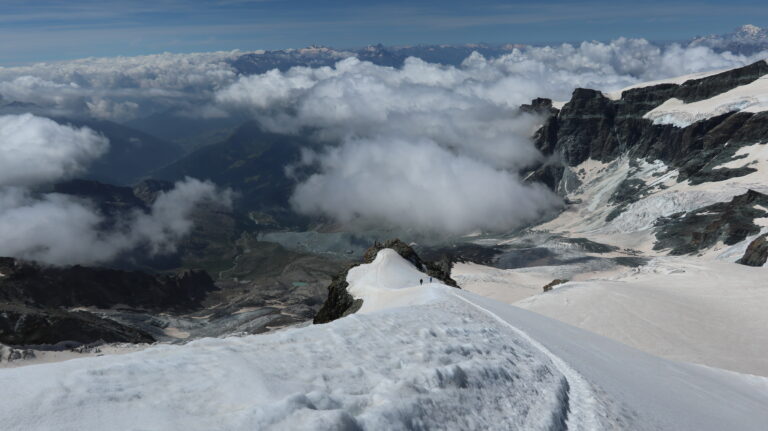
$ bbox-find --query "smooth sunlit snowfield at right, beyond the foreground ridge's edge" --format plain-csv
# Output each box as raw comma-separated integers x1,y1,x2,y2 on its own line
456,256,768,376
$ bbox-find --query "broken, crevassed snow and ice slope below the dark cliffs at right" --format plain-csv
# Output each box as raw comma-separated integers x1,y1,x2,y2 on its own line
534,151,768,253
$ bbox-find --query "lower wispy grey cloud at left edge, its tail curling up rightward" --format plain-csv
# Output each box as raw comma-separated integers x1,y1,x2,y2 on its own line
0,179,230,265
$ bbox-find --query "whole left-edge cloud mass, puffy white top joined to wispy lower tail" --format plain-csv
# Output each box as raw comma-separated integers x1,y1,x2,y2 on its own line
0,114,231,265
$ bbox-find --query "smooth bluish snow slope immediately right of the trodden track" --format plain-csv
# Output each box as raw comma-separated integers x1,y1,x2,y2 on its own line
461,293,768,430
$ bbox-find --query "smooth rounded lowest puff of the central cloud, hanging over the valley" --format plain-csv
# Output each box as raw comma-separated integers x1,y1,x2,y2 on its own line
292,138,560,234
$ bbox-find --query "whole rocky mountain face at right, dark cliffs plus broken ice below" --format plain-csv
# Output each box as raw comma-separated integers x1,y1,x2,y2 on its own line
523,61,768,262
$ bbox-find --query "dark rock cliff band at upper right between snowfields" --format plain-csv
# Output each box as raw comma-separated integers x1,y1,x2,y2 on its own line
526,61,768,194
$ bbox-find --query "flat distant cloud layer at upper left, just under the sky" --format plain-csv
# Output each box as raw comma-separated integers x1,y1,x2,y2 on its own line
0,51,242,121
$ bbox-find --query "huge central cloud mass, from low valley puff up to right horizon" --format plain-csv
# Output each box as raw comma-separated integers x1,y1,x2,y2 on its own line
217,39,768,234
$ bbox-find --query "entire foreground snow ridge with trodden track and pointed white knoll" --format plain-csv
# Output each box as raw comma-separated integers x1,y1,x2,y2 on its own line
0,250,768,430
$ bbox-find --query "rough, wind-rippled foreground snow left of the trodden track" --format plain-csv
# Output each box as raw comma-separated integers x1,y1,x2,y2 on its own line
0,290,568,431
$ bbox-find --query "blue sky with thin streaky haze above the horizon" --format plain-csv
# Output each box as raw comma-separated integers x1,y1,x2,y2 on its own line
0,0,768,65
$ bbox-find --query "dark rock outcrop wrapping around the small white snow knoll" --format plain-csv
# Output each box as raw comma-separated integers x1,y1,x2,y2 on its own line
313,239,458,324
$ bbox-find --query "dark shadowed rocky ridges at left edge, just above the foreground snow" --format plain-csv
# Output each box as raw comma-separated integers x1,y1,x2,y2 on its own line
0,258,217,345
